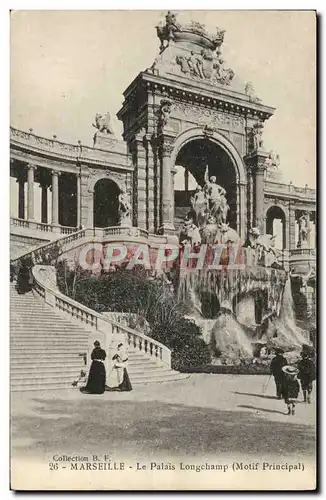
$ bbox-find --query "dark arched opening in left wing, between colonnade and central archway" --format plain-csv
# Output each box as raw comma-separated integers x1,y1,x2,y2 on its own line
94,179,120,227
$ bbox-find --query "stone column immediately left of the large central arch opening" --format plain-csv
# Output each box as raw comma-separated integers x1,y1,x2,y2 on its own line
161,143,175,234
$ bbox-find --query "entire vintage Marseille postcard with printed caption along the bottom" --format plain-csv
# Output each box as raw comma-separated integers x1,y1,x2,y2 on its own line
10,10,317,491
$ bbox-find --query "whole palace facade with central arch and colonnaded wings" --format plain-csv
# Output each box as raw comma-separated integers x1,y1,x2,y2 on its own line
10,13,316,316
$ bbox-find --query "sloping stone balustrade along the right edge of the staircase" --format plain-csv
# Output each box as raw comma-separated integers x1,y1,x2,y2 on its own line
32,265,171,368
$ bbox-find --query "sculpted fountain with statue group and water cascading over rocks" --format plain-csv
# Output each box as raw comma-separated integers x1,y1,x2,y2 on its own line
178,168,307,358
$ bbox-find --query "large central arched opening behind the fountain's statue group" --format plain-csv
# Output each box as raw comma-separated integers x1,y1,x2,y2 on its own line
174,138,238,230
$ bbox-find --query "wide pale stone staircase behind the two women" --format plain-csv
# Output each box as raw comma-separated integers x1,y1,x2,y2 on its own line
10,284,186,391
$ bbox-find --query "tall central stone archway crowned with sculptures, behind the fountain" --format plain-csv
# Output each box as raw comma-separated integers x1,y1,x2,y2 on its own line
117,12,274,239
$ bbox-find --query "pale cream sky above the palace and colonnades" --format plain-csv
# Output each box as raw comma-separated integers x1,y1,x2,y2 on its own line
11,10,316,187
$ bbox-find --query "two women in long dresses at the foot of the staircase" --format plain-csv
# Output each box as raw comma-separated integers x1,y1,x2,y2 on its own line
79,340,132,394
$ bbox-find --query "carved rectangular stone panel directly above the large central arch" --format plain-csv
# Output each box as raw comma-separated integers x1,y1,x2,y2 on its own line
171,102,244,130
